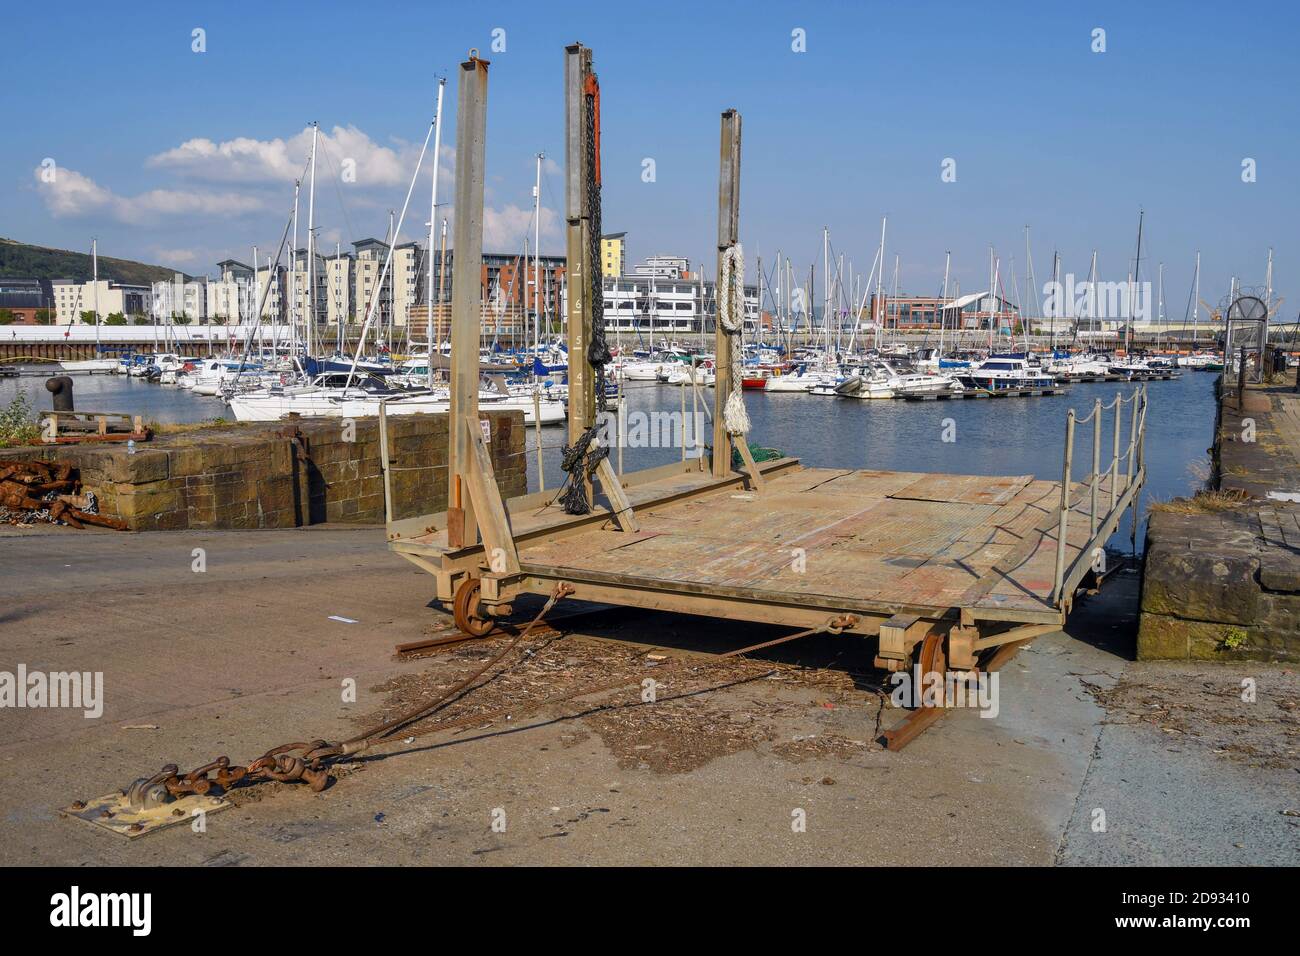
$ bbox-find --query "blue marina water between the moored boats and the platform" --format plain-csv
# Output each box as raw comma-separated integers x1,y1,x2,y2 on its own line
0,372,1217,548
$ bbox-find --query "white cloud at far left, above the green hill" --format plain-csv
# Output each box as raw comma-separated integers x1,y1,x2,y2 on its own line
33,166,263,224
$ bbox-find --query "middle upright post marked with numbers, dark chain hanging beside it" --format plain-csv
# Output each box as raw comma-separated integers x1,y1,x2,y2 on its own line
564,43,595,445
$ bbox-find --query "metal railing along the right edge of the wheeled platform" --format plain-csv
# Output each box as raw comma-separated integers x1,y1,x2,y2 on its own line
1052,385,1147,606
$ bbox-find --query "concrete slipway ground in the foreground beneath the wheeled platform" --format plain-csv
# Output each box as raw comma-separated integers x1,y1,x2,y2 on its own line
0,525,1300,865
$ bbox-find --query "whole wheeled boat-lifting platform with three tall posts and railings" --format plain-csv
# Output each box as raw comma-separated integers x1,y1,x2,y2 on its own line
380,46,1147,747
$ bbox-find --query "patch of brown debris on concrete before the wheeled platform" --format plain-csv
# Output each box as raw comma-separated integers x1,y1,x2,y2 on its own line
355,632,887,774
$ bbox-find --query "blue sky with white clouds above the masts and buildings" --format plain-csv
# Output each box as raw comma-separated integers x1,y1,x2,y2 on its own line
0,1,1300,316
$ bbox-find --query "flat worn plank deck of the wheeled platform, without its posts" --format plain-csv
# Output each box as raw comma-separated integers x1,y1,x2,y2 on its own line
389,458,1127,647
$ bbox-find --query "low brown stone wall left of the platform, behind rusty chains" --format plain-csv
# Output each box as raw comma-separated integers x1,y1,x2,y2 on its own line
0,411,528,531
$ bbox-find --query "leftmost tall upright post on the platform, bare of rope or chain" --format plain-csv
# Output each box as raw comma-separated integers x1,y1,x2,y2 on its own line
447,57,488,542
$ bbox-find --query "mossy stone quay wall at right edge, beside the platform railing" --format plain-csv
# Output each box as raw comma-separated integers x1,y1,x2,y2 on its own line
1138,369,1300,662
